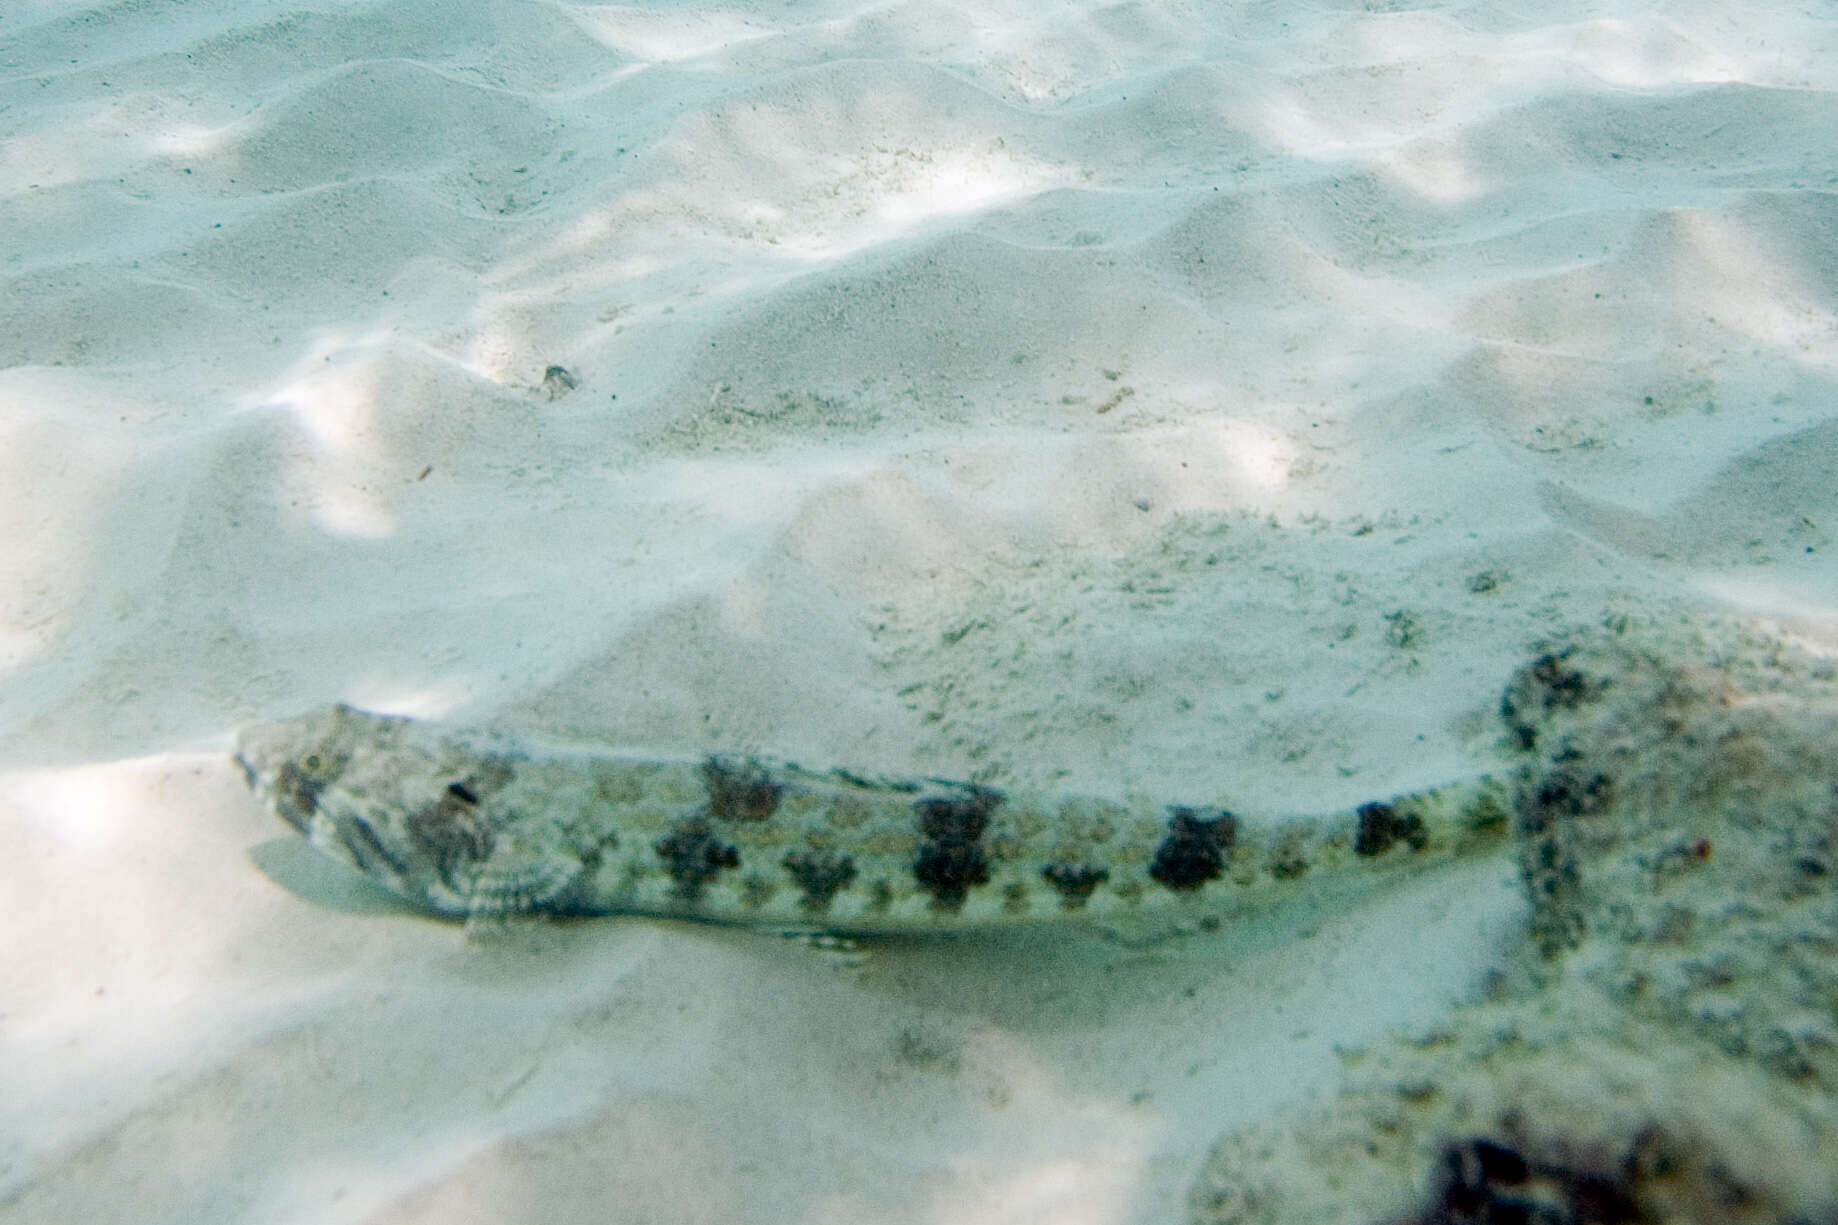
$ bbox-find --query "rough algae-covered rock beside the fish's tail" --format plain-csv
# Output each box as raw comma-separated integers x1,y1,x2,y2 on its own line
1191,620,1838,1225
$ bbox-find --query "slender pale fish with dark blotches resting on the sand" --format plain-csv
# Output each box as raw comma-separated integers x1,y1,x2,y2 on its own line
235,706,1511,933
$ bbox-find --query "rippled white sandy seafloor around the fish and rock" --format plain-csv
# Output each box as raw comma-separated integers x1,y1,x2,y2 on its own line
0,0,1838,1225
